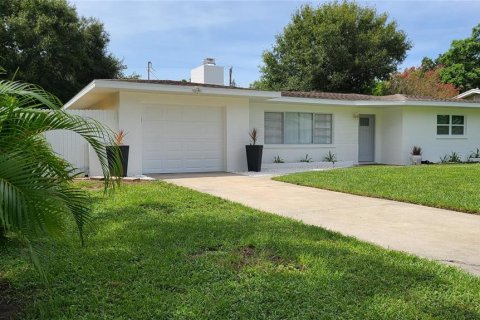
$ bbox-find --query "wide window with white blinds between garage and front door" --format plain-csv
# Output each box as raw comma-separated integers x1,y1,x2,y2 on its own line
264,112,332,144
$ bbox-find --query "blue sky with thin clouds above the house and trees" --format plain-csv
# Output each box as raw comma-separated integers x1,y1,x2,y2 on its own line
70,0,480,87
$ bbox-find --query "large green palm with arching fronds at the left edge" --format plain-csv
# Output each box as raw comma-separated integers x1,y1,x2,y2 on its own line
0,81,120,248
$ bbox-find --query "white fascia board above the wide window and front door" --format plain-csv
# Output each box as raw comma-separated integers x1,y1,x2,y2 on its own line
268,97,480,108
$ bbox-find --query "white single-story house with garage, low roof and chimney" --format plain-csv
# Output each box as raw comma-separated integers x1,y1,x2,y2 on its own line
58,61,480,176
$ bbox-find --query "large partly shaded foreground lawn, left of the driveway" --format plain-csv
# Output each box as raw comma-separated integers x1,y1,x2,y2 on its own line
0,181,480,319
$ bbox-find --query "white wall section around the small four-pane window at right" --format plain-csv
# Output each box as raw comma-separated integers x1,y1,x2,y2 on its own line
401,107,480,164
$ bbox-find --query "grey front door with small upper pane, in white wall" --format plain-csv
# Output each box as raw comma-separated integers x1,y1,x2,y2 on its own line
358,115,375,162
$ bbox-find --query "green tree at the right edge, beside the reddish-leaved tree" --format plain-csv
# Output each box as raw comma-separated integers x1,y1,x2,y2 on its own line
436,24,480,91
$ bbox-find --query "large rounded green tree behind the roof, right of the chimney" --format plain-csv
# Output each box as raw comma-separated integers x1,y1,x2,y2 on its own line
252,1,411,92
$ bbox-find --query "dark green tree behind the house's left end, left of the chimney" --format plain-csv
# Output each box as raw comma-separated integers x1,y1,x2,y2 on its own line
0,0,124,102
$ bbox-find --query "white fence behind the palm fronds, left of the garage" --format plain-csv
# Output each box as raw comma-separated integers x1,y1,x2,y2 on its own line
45,110,118,174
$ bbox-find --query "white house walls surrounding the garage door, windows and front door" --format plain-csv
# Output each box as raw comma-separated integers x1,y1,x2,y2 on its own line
78,87,480,176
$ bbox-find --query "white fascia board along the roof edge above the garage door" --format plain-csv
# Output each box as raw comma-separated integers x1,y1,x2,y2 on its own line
95,80,281,98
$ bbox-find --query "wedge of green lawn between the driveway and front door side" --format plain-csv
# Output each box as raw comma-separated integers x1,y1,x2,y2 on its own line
275,164,480,214
